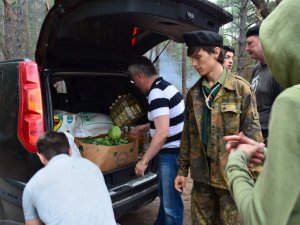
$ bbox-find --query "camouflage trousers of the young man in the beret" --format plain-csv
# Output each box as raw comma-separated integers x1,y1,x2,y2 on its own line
191,182,242,225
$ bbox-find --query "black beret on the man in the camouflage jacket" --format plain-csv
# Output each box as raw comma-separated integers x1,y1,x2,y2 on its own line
183,31,223,47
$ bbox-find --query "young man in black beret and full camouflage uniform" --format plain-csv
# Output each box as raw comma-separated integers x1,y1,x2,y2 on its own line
175,31,262,225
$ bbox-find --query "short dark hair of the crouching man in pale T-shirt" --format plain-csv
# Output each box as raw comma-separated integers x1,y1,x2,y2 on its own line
36,131,70,161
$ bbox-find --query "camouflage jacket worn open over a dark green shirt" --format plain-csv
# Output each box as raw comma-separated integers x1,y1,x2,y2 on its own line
178,73,262,189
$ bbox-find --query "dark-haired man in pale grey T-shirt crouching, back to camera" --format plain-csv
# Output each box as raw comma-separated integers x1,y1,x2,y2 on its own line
22,131,116,225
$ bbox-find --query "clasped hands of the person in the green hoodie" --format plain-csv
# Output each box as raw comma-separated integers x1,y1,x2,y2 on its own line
224,132,265,164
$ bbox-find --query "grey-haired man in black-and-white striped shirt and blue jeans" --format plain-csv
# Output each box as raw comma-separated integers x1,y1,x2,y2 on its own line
128,57,184,225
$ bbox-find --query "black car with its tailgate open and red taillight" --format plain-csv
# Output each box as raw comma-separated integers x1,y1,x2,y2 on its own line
0,0,232,221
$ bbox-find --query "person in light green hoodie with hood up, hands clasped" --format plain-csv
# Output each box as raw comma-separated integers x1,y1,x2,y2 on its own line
224,0,300,225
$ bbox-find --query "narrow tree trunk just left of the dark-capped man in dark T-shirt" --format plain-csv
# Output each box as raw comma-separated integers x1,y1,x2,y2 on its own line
237,0,248,77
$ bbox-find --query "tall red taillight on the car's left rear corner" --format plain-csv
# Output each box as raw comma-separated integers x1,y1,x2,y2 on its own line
18,61,45,153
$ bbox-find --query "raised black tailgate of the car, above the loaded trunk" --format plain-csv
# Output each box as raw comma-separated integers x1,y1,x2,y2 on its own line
36,0,232,70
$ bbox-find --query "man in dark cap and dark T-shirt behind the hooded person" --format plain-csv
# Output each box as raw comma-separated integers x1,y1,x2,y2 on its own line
246,25,283,143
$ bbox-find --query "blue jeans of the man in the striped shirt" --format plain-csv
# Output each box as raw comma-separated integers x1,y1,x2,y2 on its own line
154,153,183,225
